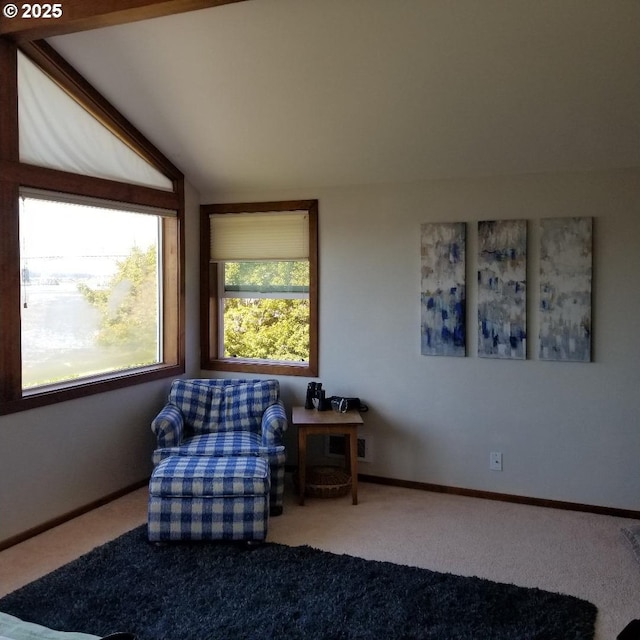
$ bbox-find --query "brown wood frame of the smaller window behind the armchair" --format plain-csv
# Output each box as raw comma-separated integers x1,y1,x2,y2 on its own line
200,200,319,377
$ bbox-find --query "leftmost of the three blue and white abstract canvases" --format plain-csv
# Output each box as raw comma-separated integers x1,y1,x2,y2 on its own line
420,222,466,356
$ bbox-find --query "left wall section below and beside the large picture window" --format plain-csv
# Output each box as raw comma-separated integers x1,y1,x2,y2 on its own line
0,180,199,543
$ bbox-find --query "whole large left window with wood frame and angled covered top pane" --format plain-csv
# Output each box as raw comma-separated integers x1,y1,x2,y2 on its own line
0,42,184,414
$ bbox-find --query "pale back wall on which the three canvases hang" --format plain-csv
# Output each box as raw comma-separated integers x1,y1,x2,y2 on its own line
203,170,640,510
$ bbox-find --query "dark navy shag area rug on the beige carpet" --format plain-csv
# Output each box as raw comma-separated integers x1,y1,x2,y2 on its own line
0,526,596,640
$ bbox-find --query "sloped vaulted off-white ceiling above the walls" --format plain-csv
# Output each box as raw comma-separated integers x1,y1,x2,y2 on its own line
15,0,640,195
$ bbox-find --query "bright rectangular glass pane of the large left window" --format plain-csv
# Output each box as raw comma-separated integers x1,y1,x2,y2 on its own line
20,191,175,390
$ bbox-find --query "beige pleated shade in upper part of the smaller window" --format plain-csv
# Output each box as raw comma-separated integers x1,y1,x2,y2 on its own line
209,211,309,262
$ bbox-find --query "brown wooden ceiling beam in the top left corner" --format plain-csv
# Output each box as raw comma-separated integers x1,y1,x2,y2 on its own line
0,0,247,42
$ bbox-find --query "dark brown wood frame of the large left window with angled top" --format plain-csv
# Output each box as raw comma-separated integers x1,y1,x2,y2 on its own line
0,38,185,415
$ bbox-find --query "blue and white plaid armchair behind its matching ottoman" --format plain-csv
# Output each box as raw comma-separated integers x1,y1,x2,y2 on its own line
151,378,288,515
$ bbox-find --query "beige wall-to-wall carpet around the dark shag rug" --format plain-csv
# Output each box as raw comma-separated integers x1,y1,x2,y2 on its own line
0,483,640,640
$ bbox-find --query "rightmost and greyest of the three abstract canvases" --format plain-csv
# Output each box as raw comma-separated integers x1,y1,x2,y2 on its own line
539,218,593,362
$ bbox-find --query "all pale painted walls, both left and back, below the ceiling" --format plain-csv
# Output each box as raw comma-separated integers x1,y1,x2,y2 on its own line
0,170,640,543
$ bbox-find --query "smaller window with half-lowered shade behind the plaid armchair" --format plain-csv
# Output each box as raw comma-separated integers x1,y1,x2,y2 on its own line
202,200,318,376
